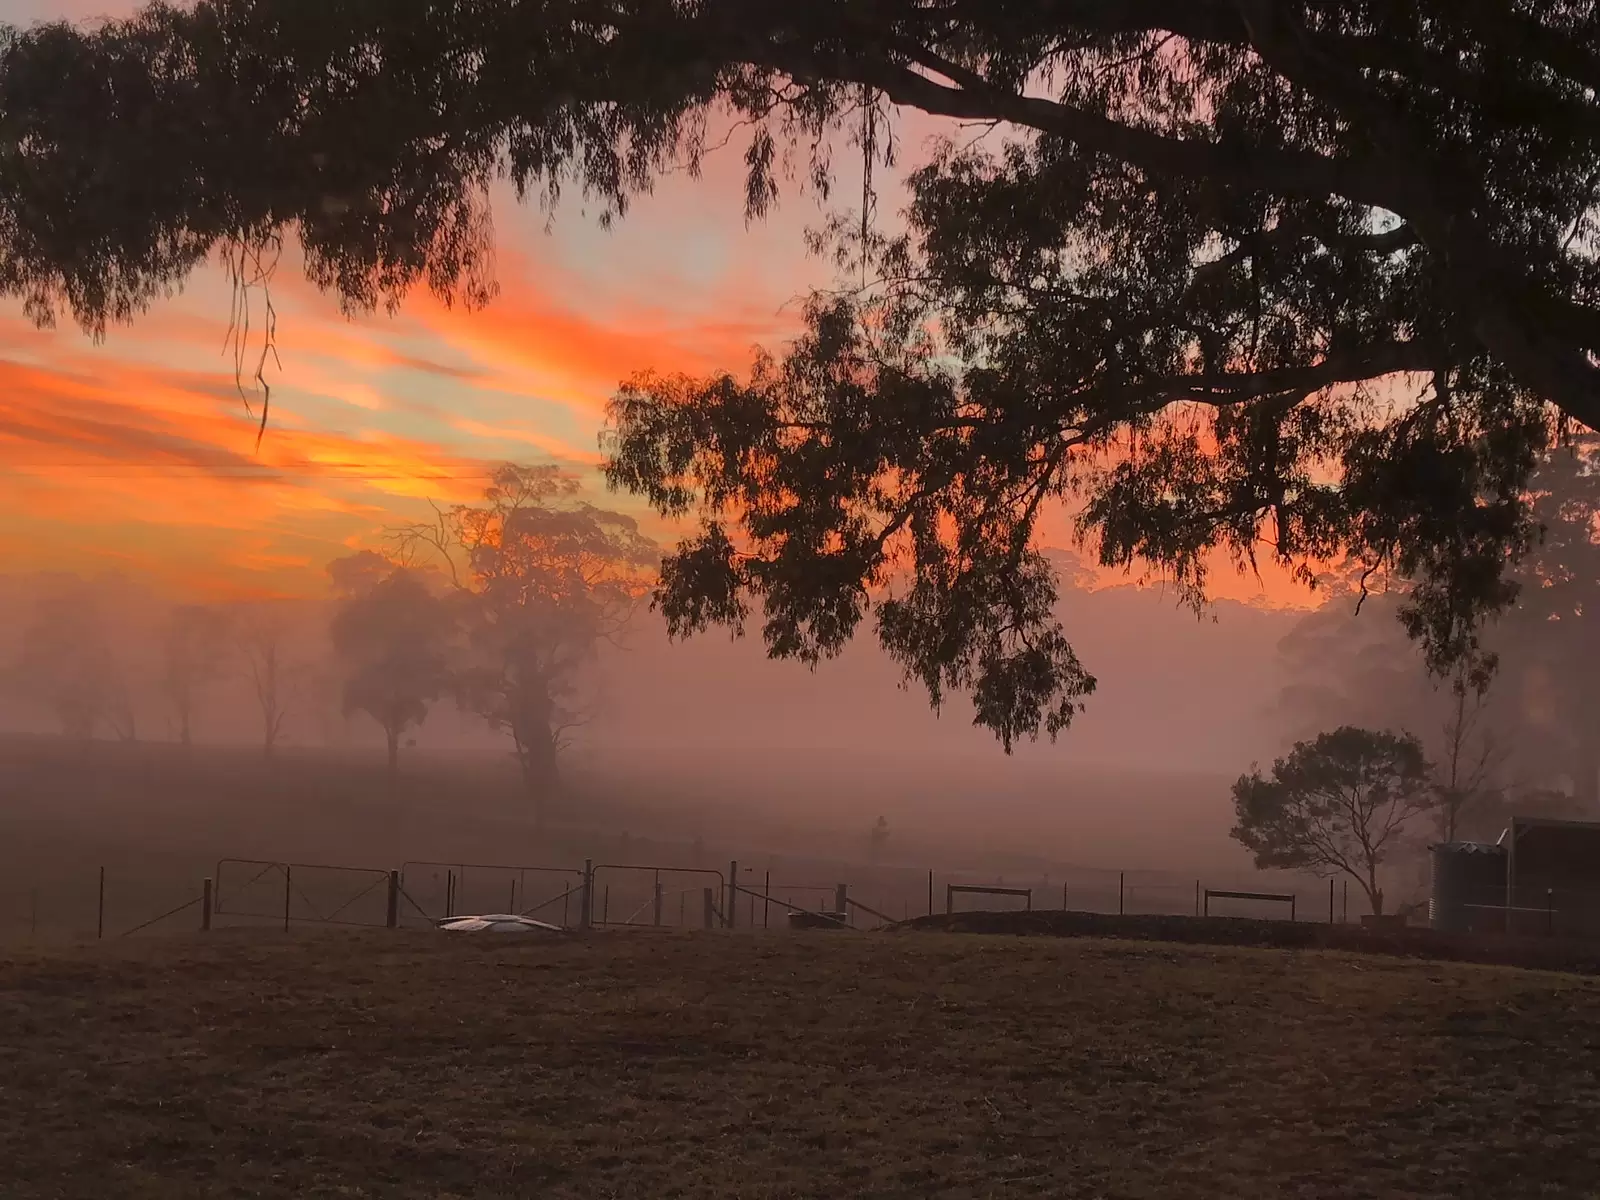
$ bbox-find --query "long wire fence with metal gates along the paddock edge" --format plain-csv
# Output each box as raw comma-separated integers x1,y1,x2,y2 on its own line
0,859,1395,944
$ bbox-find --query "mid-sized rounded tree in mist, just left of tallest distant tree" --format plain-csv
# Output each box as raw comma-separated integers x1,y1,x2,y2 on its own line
328,552,454,774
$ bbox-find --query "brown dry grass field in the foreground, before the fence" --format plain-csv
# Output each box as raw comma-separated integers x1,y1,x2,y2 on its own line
0,931,1600,1200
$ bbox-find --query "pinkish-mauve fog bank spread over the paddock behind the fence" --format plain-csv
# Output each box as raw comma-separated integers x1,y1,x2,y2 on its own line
0,524,1592,902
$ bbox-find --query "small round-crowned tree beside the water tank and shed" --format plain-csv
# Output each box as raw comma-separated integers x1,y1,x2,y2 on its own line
1232,725,1434,914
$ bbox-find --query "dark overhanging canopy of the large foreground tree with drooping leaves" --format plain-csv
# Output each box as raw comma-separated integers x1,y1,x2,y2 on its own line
0,0,1600,746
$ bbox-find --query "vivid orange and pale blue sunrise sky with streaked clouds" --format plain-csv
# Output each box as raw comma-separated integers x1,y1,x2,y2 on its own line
0,0,1304,605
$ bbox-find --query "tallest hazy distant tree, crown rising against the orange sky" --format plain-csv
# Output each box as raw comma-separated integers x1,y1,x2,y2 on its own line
400,466,659,816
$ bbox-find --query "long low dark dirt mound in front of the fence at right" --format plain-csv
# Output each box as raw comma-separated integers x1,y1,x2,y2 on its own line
894,909,1600,974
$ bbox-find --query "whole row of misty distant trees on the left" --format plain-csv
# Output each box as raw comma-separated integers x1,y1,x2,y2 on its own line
3,466,659,811
